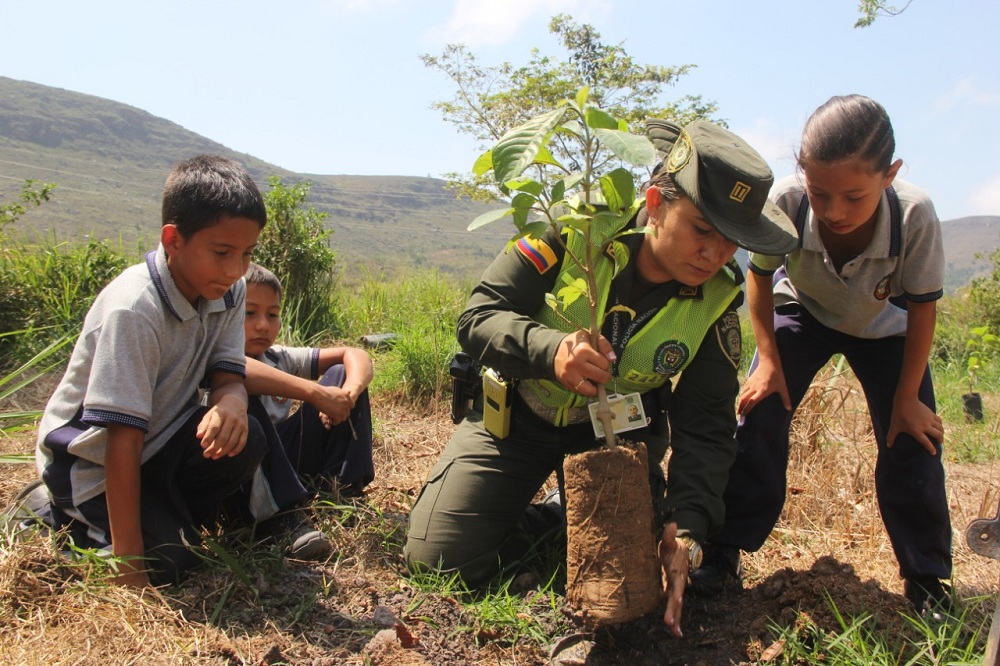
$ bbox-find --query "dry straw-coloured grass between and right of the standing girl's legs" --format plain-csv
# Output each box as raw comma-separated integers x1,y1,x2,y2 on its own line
746,367,1000,596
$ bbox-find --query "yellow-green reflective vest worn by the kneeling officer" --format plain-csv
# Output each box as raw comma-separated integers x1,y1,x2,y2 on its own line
521,224,740,426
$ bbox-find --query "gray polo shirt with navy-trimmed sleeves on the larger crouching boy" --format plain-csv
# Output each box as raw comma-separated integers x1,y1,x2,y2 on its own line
35,245,246,508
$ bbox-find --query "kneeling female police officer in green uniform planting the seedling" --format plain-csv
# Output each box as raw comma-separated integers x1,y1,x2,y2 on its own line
405,120,797,635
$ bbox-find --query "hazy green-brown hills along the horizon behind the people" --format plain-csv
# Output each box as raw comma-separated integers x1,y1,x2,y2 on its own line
0,77,1000,291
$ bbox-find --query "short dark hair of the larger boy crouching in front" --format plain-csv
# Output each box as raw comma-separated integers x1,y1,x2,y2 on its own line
162,155,267,238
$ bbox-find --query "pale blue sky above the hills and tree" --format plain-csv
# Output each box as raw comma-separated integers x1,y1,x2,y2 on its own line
0,0,1000,219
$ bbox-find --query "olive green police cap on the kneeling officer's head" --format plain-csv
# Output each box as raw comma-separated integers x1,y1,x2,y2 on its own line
646,119,799,255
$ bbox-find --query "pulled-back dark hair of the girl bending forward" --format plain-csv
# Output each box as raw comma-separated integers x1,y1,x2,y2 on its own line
798,95,896,173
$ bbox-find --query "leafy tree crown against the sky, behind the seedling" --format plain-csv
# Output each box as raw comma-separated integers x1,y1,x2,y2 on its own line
421,14,718,200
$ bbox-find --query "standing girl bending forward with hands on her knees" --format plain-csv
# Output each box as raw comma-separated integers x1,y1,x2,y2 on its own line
692,95,951,613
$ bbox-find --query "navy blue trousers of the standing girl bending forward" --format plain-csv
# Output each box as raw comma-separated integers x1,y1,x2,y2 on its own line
711,304,951,579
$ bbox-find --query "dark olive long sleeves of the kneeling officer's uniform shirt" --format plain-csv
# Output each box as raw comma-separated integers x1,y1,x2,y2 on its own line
458,220,742,541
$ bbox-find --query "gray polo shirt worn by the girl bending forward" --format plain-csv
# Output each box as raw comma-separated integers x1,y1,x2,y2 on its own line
750,176,945,339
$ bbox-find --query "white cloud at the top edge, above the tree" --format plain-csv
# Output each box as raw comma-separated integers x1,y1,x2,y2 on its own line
427,0,612,49
